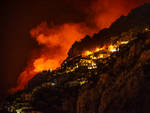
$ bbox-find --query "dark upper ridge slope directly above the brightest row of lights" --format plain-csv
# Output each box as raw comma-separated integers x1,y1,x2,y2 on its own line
68,4,150,57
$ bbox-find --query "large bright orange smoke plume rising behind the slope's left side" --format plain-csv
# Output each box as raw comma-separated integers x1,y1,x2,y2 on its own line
11,23,95,92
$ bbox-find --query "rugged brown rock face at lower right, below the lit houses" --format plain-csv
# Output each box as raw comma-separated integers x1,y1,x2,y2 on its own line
77,33,150,113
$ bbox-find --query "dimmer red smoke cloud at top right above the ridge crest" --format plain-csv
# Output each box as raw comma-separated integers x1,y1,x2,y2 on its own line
91,0,149,29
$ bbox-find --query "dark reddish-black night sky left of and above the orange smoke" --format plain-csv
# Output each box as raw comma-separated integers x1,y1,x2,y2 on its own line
0,0,95,97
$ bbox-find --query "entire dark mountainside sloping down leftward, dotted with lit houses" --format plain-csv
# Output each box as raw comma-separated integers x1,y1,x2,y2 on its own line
1,4,150,113
